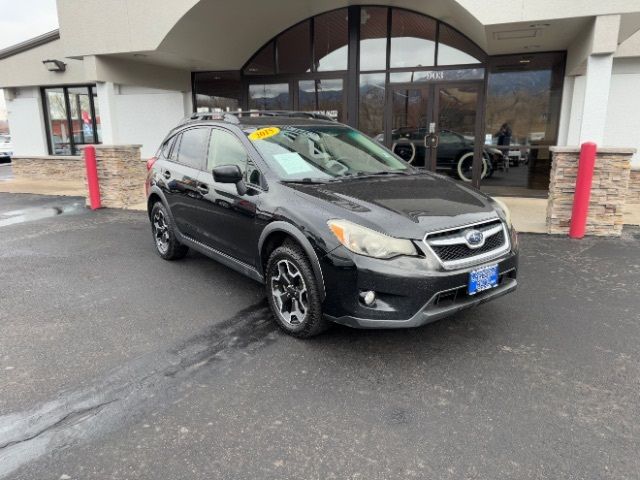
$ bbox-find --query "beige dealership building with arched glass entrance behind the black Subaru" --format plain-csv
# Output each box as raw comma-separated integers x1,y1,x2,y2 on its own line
0,0,640,218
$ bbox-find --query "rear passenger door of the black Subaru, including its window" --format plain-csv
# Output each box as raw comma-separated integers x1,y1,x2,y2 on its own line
160,127,210,237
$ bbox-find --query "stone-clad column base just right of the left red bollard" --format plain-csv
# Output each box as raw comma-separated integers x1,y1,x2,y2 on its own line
83,145,147,209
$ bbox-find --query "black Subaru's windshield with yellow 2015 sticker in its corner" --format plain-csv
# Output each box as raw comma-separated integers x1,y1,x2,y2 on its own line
245,125,412,181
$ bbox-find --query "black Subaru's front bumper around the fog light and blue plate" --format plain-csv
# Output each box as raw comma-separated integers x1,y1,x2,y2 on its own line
321,237,518,328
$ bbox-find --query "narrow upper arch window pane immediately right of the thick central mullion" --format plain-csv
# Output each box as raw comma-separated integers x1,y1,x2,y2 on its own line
360,7,388,71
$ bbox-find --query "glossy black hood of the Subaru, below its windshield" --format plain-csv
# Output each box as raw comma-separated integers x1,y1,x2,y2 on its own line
288,173,498,239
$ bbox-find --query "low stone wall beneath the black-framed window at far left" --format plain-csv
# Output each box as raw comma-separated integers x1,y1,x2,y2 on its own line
11,155,85,182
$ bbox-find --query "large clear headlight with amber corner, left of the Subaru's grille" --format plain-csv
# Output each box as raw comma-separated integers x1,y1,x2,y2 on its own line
327,220,417,258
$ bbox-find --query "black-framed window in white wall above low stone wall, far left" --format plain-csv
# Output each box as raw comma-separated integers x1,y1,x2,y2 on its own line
43,86,100,155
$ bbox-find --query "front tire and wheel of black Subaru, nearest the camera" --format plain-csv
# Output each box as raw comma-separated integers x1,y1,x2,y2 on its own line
265,242,328,338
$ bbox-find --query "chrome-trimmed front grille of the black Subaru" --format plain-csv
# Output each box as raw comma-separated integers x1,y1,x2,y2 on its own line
424,219,509,268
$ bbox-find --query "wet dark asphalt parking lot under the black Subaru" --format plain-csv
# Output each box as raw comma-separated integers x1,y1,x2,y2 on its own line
0,194,640,479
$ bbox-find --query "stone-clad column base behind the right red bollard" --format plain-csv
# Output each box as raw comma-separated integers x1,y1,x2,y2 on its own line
547,147,635,236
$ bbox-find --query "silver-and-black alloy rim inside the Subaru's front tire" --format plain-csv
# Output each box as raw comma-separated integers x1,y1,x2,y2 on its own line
270,259,309,326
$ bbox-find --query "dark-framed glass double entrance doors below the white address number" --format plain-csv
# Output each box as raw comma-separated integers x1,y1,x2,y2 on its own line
385,82,486,186
